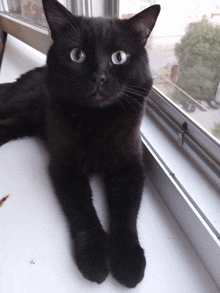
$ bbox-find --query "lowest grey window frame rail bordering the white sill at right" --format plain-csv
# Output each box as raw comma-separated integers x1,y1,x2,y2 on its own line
142,133,220,288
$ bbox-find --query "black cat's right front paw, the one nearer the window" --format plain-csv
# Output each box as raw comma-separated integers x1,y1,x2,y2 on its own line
109,236,146,288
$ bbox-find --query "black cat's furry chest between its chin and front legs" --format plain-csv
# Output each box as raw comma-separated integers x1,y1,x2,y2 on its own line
48,107,141,172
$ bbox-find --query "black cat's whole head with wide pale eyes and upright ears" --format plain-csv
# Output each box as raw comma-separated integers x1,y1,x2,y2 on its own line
43,0,160,107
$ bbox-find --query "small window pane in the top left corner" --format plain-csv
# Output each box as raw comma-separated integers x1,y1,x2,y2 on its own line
3,0,47,27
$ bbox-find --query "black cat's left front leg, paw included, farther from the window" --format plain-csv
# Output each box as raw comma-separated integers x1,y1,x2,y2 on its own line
50,163,108,284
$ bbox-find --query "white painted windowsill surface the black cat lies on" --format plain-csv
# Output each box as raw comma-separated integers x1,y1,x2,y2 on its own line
0,33,220,293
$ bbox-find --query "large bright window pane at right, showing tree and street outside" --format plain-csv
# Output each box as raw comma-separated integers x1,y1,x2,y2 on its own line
120,0,220,141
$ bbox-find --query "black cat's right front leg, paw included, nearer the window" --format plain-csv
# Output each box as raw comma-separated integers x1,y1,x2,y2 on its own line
105,164,146,288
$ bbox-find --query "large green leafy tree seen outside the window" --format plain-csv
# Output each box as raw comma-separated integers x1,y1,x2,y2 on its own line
173,19,220,101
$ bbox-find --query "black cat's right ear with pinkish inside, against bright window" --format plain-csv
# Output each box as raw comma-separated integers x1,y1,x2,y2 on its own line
128,5,160,45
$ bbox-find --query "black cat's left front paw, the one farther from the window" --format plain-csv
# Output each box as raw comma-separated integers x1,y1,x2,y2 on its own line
75,231,108,284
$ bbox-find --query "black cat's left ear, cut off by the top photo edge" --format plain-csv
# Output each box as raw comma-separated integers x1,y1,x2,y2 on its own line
42,0,77,41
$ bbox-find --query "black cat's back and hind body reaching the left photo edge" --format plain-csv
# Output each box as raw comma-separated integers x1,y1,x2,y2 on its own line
0,67,48,136
